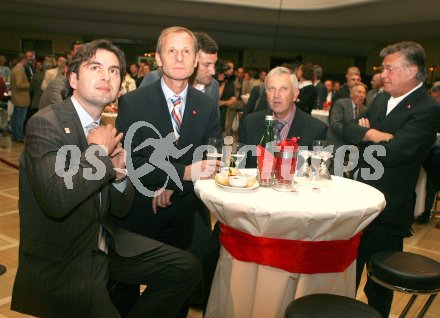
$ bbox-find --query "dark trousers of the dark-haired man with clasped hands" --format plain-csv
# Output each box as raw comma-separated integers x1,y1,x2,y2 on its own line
93,241,202,318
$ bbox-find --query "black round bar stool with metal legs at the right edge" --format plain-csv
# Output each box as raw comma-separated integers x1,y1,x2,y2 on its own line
368,251,440,318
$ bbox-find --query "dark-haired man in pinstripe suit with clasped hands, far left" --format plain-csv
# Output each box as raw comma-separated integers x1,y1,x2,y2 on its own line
11,40,201,318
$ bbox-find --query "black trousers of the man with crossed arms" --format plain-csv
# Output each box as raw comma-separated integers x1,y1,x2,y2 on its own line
356,231,403,317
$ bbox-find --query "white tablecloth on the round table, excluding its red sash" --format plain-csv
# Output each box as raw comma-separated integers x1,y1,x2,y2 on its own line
195,177,385,318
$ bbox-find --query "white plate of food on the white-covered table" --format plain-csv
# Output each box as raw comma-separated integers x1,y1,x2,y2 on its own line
215,169,260,192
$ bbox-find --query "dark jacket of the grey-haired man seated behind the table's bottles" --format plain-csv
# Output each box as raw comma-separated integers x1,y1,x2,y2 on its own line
240,107,327,168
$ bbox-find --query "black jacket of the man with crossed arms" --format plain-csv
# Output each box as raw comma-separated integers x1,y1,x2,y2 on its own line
343,87,440,237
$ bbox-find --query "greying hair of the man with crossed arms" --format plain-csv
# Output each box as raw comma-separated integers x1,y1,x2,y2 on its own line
380,41,426,82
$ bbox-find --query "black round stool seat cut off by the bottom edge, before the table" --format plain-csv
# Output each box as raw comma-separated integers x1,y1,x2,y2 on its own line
284,294,382,318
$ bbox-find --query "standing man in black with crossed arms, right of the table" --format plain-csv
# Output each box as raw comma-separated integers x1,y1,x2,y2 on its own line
343,42,440,317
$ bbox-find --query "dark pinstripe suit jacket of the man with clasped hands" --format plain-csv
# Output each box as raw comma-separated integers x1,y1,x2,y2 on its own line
11,98,162,317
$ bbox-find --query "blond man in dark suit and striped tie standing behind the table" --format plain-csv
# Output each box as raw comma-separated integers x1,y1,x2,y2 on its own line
116,27,220,249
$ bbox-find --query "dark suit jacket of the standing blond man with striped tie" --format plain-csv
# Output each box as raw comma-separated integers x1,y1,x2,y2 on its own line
114,81,221,248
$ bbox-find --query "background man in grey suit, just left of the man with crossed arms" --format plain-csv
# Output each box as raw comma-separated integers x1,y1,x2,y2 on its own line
327,83,366,153
